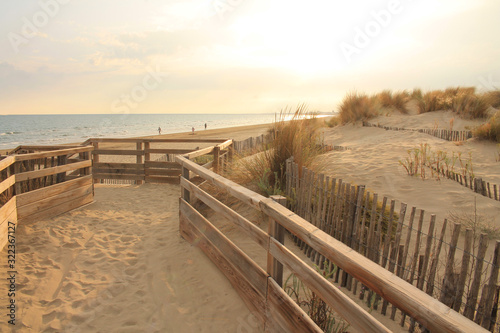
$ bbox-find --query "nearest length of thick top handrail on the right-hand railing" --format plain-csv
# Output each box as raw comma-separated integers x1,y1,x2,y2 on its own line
261,199,487,333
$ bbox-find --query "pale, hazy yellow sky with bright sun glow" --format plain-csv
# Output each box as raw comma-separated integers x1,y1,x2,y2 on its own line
0,0,500,115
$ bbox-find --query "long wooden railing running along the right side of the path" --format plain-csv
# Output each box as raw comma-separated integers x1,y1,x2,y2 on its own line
176,156,485,332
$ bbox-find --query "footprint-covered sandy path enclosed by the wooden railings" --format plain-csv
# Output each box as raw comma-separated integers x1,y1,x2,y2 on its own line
0,184,249,332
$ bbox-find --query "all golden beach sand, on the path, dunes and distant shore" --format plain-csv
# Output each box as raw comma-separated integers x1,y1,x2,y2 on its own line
0,113,500,332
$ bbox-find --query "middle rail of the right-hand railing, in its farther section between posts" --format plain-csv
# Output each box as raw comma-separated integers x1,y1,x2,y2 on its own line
181,178,269,250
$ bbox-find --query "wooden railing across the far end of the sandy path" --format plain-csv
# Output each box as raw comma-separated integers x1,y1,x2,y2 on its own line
85,139,232,184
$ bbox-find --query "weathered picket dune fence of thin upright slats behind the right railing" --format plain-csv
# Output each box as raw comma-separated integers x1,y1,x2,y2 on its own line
286,160,500,332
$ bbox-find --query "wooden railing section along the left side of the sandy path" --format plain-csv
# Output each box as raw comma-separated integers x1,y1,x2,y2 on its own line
0,146,93,249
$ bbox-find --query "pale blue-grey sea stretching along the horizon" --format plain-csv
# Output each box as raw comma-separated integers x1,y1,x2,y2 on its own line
0,113,279,150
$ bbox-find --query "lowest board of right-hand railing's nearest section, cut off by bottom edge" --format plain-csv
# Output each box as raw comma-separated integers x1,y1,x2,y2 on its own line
266,278,323,333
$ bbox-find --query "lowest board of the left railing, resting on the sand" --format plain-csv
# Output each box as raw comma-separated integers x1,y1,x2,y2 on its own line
17,185,92,219
